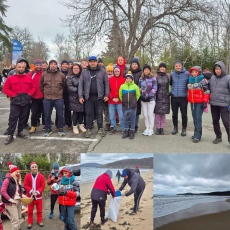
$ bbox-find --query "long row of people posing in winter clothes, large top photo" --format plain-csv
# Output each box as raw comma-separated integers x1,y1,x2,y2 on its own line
3,56,230,144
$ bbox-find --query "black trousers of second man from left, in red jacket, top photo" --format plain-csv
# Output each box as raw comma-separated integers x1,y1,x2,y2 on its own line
31,98,45,126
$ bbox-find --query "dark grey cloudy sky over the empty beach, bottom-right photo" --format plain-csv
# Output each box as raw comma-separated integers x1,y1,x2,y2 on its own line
154,154,230,194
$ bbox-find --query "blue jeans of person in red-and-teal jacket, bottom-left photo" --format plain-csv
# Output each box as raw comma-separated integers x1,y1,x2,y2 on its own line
61,205,77,230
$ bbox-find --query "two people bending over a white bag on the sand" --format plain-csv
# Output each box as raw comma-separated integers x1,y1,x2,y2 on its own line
90,168,145,229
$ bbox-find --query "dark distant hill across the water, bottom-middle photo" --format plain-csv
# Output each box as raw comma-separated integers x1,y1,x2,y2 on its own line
100,157,153,169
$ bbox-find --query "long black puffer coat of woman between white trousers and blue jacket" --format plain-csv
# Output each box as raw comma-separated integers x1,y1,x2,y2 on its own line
154,72,170,114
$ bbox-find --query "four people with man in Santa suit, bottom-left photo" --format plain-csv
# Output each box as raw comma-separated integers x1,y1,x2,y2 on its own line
1,162,79,230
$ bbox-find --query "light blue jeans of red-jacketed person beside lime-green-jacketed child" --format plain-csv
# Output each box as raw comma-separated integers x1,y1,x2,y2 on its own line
109,104,125,131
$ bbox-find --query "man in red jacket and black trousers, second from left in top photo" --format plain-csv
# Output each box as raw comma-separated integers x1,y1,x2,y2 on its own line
28,59,45,134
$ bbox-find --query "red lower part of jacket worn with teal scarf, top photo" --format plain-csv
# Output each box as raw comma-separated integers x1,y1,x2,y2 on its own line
188,88,210,103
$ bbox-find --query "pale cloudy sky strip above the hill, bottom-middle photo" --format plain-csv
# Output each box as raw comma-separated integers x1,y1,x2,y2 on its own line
81,153,153,164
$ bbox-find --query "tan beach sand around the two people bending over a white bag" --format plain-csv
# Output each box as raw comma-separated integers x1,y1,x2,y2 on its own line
81,170,153,230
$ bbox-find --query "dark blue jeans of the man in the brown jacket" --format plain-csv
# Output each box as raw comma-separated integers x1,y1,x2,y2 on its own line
43,99,65,129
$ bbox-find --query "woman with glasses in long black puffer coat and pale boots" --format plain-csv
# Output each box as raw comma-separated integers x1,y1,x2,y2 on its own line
66,64,86,134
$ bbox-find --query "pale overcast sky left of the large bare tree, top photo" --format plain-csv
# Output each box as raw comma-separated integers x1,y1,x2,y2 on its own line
4,0,103,56
